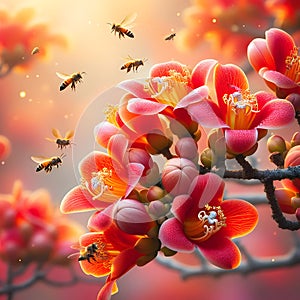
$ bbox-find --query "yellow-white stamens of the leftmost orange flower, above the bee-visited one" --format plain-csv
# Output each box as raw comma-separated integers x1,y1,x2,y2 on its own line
82,167,113,200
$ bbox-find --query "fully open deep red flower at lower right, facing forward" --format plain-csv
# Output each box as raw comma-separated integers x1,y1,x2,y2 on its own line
159,173,258,269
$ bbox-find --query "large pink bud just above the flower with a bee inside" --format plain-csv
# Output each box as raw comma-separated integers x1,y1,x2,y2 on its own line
113,199,155,235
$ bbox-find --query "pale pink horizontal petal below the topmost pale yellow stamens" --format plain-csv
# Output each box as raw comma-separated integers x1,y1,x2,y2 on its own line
127,98,168,115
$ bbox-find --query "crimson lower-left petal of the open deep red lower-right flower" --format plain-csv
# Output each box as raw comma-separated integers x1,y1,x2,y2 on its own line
158,218,194,252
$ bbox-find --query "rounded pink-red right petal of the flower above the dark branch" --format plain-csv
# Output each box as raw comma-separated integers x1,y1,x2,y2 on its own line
253,99,295,129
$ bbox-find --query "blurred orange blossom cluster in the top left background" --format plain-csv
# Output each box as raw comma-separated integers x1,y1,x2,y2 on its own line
0,8,66,77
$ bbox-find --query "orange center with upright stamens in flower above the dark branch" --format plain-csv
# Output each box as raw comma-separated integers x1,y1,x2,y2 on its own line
223,90,259,130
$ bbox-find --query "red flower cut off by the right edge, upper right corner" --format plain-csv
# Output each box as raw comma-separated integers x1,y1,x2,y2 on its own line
248,28,300,98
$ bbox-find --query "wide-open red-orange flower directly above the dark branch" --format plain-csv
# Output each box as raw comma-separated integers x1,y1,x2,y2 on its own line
178,61,295,155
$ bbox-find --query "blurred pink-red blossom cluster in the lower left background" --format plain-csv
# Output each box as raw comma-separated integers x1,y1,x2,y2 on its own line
0,181,83,266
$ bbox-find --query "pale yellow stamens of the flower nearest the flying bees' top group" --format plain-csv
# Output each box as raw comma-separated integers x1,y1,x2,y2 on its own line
145,69,190,107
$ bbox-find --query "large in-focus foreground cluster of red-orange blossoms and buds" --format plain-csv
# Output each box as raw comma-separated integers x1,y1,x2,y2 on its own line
61,29,298,299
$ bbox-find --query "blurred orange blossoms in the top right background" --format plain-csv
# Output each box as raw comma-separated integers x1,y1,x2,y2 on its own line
175,0,300,58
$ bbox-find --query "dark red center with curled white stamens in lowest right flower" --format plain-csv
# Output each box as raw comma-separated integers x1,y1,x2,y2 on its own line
184,204,226,242
